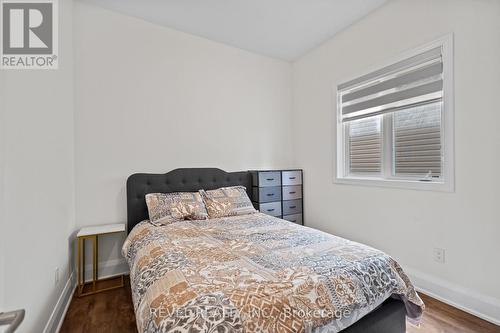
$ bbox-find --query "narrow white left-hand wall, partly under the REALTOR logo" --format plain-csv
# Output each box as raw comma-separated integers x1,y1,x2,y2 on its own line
0,0,74,333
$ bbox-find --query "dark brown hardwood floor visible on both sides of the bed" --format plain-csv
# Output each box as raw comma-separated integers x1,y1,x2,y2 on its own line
60,277,500,333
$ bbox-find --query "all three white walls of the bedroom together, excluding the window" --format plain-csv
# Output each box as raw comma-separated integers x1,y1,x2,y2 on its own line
0,0,500,332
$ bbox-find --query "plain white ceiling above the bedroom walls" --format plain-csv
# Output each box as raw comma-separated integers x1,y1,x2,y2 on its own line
83,0,386,61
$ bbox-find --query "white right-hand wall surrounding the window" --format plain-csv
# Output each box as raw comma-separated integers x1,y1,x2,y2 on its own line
293,0,500,322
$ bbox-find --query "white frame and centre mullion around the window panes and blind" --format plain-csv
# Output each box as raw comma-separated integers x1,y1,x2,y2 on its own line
333,33,455,192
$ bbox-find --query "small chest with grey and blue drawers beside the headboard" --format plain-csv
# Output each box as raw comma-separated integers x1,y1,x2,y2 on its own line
250,169,304,225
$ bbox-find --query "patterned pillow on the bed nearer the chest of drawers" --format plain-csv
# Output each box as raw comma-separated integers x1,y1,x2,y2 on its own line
200,186,257,218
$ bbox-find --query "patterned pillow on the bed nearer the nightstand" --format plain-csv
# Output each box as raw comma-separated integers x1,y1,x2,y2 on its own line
146,192,208,225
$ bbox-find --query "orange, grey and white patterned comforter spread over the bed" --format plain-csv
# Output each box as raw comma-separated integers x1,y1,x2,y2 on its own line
122,213,424,333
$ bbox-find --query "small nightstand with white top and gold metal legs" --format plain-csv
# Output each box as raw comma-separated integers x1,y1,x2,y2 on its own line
76,223,125,296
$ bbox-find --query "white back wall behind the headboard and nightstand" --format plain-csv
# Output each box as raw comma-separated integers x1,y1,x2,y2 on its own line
74,2,292,274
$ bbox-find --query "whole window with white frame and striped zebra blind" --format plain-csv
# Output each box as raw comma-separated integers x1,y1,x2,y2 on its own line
336,36,453,191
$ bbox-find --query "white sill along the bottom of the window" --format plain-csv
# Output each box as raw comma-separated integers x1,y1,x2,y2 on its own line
333,176,454,192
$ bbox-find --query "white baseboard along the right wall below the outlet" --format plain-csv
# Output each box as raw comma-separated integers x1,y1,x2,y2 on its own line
404,267,500,326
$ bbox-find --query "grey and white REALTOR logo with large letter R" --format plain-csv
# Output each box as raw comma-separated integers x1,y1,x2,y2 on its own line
0,0,58,69
